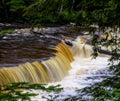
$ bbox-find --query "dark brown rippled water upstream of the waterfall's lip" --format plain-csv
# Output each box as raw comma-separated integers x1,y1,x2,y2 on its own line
0,34,60,67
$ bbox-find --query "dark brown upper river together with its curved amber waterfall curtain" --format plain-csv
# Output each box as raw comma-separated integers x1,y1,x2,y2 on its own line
0,32,73,85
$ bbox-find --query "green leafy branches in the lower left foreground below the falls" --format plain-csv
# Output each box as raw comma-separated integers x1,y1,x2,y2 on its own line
0,82,62,101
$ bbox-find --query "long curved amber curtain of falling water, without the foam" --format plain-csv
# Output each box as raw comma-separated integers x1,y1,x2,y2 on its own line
0,42,73,85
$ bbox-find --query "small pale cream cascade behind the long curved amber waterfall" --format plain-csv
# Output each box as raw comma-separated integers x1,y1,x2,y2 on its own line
71,36,93,58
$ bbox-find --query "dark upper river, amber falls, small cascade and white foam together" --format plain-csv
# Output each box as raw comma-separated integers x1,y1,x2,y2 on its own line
0,31,112,101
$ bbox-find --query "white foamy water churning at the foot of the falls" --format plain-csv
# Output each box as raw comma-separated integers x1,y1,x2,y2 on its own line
31,57,111,101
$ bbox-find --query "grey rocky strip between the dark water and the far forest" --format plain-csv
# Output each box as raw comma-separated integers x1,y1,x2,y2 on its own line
0,26,73,40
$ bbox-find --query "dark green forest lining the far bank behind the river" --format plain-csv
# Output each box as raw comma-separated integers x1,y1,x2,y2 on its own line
0,0,120,27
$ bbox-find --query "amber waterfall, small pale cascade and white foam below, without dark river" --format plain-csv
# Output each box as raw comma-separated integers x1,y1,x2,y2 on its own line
0,36,111,101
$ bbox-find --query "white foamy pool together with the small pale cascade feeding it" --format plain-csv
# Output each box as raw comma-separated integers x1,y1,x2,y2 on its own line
32,37,112,101
